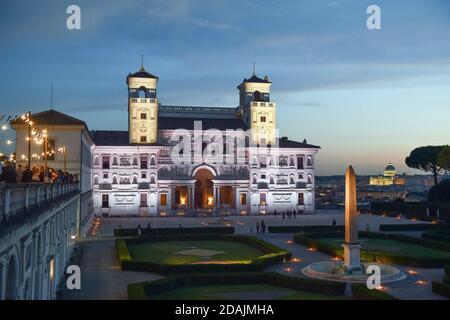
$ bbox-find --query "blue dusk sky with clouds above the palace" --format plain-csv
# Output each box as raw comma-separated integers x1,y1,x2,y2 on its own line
0,0,450,175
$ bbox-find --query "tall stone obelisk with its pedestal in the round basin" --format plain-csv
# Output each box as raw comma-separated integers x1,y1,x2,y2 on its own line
342,166,362,274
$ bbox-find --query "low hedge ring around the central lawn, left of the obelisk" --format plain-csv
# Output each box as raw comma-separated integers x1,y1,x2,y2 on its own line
116,234,292,275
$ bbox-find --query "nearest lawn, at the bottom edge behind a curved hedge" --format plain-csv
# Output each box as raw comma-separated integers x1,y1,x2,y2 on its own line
150,284,348,300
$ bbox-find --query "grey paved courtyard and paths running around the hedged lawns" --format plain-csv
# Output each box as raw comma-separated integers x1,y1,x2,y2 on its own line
60,210,444,300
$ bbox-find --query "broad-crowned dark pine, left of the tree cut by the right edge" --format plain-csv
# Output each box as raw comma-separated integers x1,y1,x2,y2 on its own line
405,146,446,185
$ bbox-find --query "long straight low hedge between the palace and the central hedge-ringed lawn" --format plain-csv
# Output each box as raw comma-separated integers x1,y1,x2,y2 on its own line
114,227,234,237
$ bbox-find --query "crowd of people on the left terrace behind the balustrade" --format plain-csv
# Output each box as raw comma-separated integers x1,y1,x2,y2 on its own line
0,161,75,183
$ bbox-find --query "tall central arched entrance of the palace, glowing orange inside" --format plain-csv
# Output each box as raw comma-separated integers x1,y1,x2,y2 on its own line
194,168,214,209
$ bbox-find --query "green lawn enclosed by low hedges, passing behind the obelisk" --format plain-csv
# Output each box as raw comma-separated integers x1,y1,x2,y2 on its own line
316,238,450,259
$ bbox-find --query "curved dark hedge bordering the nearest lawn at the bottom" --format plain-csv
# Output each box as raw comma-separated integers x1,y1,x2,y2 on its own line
128,272,345,300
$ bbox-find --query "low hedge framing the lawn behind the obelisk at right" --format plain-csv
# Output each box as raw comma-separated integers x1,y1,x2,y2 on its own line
294,231,450,268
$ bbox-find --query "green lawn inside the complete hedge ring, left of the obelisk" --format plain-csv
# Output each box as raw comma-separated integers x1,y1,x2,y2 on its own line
128,240,265,265
